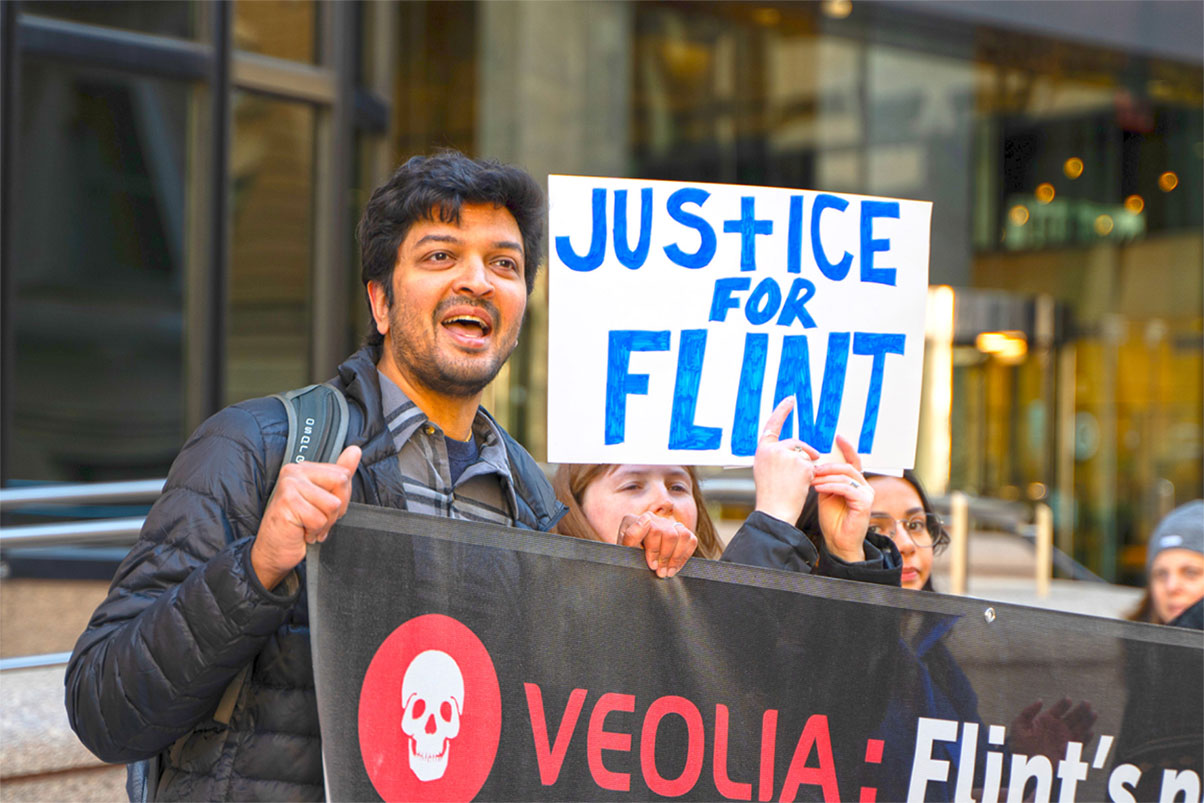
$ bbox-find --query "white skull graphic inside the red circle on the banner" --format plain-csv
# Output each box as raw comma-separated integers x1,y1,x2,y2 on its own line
401,650,464,781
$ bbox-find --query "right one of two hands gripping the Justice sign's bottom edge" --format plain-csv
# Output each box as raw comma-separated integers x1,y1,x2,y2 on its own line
811,435,874,562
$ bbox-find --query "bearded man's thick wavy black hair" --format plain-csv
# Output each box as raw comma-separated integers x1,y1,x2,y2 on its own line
355,150,545,344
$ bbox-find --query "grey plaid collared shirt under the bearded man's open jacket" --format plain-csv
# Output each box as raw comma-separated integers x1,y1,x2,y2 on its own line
377,371,517,526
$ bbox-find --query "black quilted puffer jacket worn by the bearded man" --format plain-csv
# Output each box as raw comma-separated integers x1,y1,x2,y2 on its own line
66,347,563,801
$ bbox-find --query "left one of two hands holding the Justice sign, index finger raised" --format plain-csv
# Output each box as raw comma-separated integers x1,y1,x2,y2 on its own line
753,396,820,524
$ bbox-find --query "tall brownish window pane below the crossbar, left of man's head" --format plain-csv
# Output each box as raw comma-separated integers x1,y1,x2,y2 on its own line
226,91,315,402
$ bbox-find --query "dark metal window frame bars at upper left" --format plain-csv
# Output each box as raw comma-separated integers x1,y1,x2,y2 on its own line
0,0,391,485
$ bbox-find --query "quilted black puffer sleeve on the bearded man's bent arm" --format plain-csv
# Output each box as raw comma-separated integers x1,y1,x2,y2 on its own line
66,400,300,762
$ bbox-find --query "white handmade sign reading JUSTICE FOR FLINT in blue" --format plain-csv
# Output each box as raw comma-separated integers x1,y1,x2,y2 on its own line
548,176,932,471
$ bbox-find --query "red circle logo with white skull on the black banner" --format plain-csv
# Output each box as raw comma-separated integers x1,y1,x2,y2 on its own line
359,614,502,801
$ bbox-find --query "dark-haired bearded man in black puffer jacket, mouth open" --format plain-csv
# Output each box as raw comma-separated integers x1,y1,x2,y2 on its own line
66,152,692,801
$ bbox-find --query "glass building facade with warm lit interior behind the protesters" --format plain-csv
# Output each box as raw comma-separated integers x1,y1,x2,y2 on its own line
0,0,1204,580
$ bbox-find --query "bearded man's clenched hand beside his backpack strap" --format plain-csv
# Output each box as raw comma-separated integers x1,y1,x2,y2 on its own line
250,445,360,590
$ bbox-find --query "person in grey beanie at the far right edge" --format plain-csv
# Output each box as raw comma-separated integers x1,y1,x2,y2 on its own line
1129,500,1204,627
